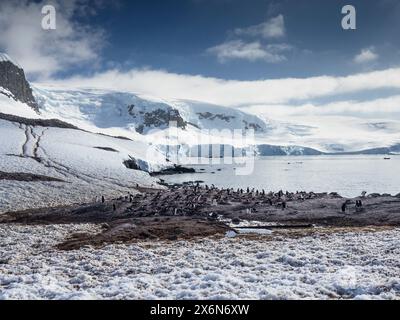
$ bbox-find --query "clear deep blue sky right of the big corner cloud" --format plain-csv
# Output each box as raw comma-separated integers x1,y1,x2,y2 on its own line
88,0,400,80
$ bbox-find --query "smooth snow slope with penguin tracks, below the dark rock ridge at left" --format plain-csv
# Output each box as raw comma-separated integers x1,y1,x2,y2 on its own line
0,115,167,213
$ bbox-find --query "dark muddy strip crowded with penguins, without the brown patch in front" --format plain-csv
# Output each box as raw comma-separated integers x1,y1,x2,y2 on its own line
0,186,400,227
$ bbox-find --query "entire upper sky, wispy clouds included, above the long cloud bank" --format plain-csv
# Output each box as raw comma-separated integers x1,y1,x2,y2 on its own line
0,0,400,80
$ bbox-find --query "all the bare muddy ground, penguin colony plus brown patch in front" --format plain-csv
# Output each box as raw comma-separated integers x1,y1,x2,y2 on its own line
0,186,400,250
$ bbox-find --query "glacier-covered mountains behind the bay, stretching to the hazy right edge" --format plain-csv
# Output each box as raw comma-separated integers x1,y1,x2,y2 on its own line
33,84,400,155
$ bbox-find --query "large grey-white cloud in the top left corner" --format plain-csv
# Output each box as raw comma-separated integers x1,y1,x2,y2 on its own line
0,0,104,78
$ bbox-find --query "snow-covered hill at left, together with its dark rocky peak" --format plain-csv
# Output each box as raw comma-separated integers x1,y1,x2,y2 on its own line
0,55,171,213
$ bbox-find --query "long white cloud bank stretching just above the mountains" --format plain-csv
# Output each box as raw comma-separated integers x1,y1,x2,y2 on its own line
41,68,400,107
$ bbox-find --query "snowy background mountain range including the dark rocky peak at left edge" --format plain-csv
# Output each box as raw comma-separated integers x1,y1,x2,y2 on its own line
0,54,400,156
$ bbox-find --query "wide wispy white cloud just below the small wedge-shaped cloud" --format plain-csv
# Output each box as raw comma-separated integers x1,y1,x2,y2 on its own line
207,40,290,63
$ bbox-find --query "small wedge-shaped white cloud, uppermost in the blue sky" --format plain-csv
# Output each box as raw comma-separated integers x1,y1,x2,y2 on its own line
234,14,285,39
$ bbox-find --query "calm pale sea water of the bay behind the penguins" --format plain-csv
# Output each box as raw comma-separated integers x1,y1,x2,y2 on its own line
161,155,400,197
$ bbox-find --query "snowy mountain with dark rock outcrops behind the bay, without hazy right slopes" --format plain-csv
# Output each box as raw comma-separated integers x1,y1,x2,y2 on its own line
34,85,268,142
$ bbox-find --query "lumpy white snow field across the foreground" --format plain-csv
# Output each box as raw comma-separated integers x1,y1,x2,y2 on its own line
0,225,400,299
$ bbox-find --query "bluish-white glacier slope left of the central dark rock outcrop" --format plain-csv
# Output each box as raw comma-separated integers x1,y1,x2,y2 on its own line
34,86,172,138
